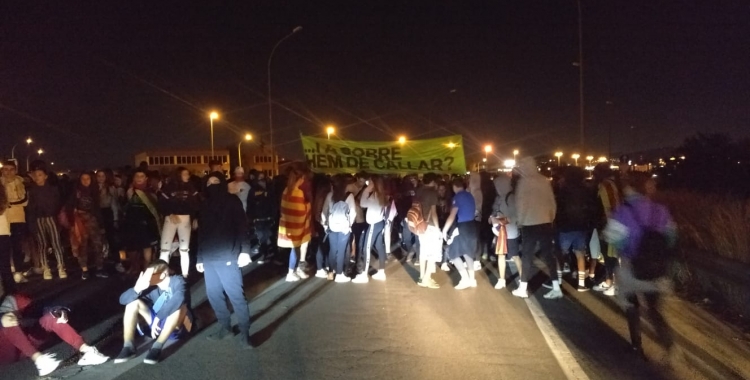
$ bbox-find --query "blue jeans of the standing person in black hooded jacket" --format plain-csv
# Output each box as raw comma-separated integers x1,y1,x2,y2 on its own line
203,262,250,335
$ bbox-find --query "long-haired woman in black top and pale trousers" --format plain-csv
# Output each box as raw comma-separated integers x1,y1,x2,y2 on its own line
159,167,199,278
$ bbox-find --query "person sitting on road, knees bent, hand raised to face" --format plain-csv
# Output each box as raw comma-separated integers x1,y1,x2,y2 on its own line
115,260,188,364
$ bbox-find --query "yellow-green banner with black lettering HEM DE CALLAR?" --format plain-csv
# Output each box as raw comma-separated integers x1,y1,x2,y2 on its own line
302,135,466,174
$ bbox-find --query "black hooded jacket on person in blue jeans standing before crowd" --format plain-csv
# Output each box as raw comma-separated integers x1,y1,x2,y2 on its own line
198,173,250,264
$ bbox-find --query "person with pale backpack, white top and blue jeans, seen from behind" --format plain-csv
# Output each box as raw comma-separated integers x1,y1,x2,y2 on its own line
320,175,357,283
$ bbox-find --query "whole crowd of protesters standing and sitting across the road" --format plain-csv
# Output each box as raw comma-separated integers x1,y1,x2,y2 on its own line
0,154,674,373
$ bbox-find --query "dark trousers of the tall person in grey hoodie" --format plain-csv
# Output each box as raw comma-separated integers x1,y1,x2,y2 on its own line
521,223,557,282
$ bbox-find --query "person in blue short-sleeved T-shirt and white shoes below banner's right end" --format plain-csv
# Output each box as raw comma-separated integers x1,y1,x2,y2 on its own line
443,178,479,290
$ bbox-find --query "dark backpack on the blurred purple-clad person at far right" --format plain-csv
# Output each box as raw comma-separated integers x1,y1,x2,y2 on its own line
625,203,674,281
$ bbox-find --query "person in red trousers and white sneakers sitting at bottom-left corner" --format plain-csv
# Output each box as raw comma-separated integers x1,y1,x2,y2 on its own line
0,293,109,376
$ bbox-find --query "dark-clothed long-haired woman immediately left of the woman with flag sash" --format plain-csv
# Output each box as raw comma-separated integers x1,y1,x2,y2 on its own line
96,169,122,272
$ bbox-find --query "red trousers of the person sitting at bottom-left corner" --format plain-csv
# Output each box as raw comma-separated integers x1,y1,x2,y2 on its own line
0,314,83,365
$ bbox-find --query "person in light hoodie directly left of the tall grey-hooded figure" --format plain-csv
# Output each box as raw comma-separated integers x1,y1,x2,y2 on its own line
489,173,523,289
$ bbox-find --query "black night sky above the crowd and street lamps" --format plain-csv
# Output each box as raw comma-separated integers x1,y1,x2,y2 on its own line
0,0,750,169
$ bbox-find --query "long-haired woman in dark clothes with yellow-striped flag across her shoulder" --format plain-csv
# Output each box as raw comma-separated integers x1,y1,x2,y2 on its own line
120,169,161,273
